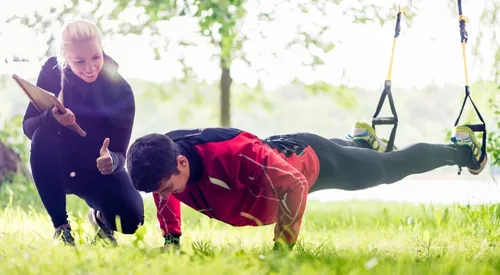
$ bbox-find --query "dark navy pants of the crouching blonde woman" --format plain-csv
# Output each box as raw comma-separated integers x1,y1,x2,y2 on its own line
30,127,144,234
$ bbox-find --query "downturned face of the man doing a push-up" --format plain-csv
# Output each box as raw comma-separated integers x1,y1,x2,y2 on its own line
153,155,189,199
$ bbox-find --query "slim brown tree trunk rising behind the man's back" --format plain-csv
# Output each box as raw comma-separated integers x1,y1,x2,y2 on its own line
220,58,233,127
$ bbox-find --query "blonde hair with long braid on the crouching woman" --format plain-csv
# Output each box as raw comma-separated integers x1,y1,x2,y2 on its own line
57,19,102,102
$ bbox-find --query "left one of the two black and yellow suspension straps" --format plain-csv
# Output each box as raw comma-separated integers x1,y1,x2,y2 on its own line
372,7,407,152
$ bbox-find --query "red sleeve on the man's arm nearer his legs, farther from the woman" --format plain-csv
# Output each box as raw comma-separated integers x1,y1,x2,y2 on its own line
233,133,308,245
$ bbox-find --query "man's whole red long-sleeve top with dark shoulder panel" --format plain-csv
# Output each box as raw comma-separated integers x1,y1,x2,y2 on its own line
153,128,319,244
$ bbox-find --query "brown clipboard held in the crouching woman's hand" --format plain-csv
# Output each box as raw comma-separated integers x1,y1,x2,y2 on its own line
12,74,87,137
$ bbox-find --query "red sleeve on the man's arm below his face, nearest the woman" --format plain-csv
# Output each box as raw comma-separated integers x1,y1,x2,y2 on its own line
153,193,182,236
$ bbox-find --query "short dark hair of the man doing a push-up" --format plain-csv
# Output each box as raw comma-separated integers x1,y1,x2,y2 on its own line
127,134,180,193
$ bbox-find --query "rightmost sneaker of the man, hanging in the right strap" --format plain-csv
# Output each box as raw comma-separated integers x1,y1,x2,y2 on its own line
451,125,488,175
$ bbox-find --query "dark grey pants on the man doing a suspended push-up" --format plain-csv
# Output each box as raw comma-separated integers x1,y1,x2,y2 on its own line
295,133,472,192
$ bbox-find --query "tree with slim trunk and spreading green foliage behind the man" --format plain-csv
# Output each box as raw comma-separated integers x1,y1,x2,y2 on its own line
4,0,417,126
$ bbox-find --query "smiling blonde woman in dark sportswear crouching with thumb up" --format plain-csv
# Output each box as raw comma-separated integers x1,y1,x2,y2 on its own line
23,20,144,245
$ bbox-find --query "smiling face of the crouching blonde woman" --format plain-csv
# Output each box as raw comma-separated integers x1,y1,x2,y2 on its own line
65,39,104,83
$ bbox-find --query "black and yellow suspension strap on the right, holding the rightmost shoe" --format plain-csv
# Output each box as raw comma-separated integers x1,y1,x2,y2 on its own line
455,0,486,162
